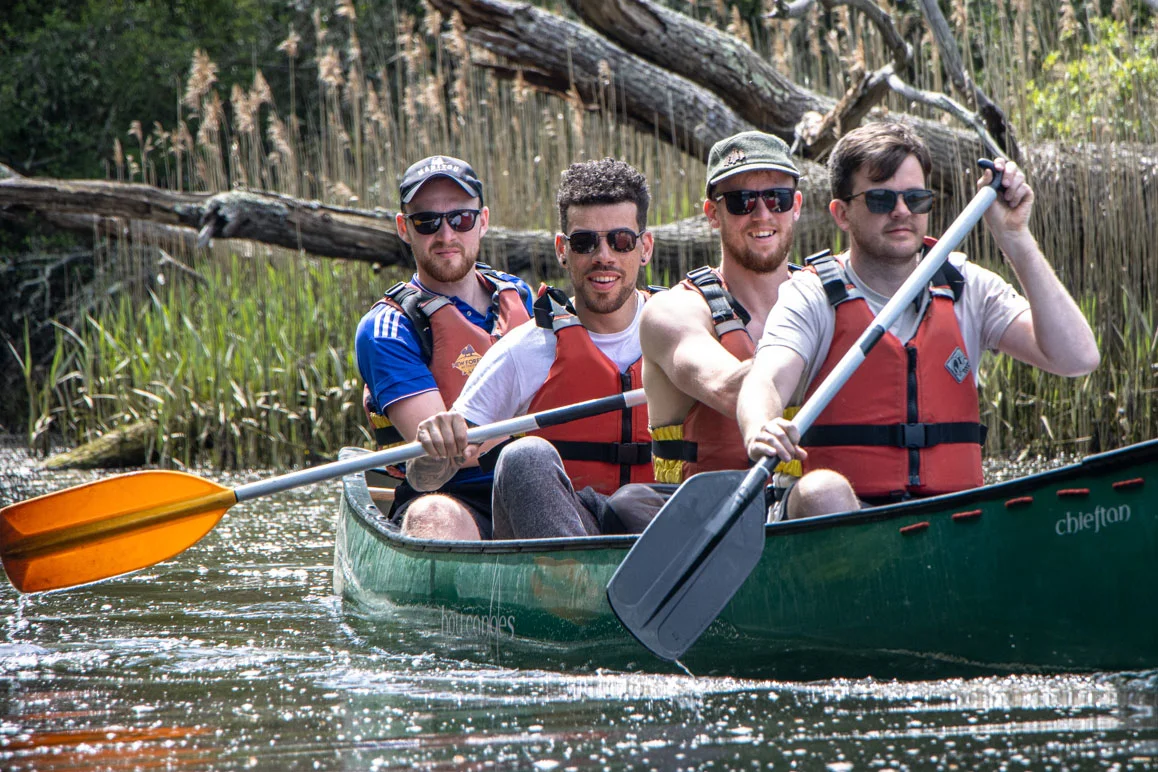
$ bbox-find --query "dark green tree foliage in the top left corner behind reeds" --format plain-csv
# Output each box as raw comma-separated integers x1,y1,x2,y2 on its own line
0,0,321,177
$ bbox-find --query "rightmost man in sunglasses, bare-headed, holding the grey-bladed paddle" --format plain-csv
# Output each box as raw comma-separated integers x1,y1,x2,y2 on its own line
739,123,1099,517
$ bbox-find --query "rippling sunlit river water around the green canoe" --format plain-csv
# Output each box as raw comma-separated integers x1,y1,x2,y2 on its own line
0,450,1158,772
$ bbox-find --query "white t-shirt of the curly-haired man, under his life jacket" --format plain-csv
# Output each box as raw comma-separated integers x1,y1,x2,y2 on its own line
453,292,644,426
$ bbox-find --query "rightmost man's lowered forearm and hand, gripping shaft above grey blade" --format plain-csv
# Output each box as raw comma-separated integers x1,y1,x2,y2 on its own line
736,346,808,461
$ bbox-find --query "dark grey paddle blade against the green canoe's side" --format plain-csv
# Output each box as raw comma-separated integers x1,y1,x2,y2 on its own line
607,471,767,660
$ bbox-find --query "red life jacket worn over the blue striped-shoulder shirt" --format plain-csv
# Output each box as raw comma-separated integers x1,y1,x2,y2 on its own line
362,263,530,448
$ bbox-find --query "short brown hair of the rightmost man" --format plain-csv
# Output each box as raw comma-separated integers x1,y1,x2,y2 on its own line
828,122,933,200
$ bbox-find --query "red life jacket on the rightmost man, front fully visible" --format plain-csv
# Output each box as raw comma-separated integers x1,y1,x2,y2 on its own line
800,248,985,503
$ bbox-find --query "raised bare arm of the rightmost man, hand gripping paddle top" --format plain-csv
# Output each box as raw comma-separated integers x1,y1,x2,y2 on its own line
979,160,1100,376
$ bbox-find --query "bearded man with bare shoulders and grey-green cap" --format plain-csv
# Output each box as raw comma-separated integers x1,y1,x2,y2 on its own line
639,132,801,483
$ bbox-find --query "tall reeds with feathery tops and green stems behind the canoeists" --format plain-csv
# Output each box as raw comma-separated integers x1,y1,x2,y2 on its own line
13,0,1158,466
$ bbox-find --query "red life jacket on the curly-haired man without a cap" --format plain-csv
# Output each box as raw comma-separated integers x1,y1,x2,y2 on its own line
529,286,655,494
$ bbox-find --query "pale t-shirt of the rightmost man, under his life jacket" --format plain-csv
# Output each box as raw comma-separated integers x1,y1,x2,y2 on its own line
757,252,1029,399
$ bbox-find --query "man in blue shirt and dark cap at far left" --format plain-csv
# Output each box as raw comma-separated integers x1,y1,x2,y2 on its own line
354,155,532,538
